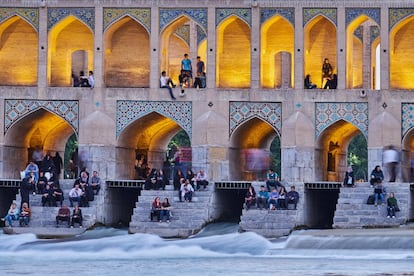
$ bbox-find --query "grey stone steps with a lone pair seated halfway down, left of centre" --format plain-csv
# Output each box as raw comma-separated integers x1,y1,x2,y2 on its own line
129,185,212,238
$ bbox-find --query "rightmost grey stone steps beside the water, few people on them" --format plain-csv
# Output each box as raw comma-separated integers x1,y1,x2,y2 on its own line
333,183,410,228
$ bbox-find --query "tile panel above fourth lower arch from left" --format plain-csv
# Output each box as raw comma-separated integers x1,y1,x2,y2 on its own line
315,103,368,138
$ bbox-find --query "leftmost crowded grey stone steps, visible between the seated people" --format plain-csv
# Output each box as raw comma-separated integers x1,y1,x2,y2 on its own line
14,179,103,229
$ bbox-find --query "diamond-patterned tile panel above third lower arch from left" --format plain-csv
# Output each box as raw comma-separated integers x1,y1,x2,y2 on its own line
229,102,282,136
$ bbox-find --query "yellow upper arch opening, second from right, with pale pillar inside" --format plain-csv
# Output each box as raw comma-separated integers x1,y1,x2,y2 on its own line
346,15,380,89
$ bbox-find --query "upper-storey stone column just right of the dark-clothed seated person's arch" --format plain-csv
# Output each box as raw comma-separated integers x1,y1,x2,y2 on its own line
336,7,347,89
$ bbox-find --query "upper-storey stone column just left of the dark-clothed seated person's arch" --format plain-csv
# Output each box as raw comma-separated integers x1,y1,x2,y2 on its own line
292,7,305,89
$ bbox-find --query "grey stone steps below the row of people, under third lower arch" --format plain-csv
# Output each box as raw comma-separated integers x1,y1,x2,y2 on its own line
239,182,304,238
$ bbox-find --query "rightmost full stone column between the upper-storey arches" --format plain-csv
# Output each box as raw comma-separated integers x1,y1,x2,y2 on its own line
377,7,390,89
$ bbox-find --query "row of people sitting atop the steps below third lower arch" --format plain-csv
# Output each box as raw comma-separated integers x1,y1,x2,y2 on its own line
244,185,299,210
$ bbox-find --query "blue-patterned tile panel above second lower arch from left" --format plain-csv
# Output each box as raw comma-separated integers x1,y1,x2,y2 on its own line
116,100,192,138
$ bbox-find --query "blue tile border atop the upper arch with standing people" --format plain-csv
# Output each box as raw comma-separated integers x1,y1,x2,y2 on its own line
159,8,207,33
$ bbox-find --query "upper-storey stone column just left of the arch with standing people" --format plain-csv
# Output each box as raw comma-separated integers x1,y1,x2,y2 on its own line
150,6,161,89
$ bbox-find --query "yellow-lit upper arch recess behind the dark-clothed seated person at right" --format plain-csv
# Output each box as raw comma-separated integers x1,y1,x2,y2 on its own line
304,15,337,88
